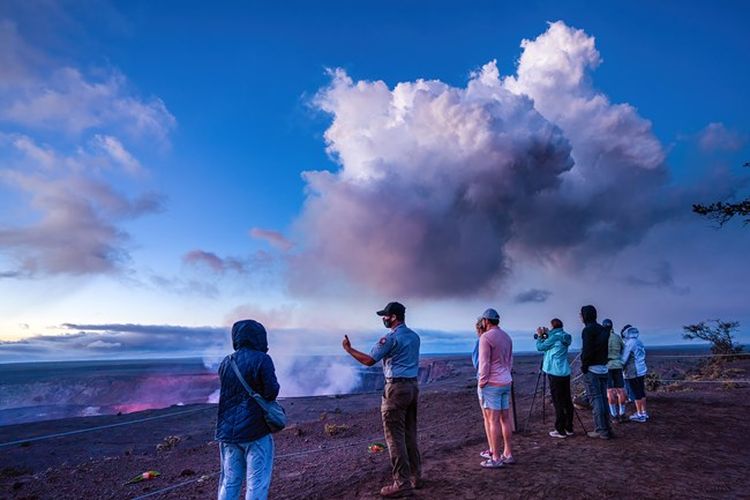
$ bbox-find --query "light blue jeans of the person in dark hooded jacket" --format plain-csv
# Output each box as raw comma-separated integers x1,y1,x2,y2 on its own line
219,434,273,500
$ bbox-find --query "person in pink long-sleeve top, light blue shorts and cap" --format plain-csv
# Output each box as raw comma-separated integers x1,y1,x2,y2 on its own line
477,309,515,469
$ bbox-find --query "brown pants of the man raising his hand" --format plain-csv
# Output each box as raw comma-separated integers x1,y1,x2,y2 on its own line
380,380,422,486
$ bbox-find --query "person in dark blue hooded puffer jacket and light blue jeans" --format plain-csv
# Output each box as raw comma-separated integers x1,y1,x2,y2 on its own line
216,319,279,500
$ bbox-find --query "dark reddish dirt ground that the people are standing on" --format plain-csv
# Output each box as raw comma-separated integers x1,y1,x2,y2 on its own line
0,359,750,499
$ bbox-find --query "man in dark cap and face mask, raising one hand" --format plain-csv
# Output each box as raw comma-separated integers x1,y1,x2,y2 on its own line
342,302,422,498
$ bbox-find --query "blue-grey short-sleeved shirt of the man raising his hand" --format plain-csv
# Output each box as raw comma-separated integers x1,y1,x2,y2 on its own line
370,323,420,378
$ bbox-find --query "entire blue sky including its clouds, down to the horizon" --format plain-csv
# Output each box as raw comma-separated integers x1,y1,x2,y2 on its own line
0,1,750,359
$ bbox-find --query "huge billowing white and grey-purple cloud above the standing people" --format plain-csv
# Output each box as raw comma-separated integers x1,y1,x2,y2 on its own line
291,22,671,297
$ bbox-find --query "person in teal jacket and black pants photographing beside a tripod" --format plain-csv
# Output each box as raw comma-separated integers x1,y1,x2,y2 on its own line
536,318,574,438
